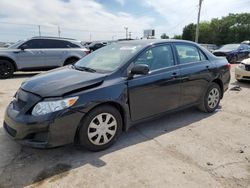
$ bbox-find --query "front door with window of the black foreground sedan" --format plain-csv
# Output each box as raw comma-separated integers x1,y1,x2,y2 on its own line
128,44,180,121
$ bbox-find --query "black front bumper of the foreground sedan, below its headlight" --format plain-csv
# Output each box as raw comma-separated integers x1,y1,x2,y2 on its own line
3,104,84,148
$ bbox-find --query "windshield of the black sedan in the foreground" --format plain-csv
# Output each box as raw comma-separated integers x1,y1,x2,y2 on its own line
75,43,142,73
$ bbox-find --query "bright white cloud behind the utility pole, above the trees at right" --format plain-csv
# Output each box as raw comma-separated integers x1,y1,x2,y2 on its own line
144,0,250,36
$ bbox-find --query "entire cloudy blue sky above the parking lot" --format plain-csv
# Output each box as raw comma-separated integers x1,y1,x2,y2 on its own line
0,0,250,42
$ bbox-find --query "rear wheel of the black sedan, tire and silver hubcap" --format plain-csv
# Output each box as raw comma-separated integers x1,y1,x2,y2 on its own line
199,82,222,113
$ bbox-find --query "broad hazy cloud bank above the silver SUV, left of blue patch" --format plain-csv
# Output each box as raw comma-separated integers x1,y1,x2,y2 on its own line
0,0,154,40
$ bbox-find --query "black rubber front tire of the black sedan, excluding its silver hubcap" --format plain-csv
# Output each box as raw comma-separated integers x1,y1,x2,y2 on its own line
78,105,122,151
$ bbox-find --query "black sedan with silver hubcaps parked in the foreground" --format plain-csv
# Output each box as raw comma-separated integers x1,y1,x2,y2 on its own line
3,40,230,151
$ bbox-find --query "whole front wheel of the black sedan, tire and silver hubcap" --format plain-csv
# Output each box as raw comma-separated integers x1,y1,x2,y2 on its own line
78,105,122,151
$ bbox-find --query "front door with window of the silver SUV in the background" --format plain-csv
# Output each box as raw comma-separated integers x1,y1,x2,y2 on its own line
15,39,45,69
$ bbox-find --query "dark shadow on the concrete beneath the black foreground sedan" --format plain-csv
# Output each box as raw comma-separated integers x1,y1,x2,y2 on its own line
0,108,217,187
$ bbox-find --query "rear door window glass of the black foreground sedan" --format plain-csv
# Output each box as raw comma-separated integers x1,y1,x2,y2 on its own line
175,44,207,64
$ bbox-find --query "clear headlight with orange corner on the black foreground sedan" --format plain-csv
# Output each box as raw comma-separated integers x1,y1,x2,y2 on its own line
32,97,78,116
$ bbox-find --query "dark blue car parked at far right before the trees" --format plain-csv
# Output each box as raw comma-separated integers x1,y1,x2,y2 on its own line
213,44,250,63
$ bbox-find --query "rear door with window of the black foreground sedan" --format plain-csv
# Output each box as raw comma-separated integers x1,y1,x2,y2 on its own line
174,43,216,106
